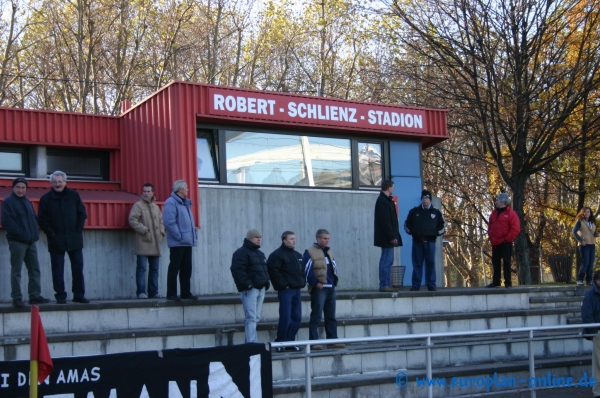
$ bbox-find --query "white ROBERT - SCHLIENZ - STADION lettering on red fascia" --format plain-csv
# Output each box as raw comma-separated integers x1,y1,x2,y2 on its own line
209,88,427,133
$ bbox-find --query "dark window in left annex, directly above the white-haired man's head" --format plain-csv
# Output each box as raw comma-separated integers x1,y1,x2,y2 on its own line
46,148,110,181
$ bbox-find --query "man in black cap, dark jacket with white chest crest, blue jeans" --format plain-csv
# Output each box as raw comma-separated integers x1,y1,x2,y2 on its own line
404,189,446,291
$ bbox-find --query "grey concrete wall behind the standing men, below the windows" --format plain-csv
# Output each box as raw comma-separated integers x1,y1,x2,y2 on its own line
0,186,390,302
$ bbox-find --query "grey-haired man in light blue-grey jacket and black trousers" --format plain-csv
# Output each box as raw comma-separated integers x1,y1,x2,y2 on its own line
163,180,198,301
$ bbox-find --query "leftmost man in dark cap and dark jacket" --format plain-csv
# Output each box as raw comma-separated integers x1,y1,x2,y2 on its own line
2,177,50,307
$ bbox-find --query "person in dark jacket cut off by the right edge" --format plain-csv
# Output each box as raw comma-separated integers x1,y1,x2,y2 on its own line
581,271,600,397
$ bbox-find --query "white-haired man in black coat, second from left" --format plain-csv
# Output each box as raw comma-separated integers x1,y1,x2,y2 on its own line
38,171,90,304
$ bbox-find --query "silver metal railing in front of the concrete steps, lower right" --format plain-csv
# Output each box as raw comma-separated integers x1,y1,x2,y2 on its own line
270,323,600,398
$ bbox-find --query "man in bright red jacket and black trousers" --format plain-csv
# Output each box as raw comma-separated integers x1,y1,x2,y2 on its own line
487,193,521,288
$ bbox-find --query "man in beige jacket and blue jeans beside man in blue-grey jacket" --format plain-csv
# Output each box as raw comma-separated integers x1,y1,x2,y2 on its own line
129,183,165,299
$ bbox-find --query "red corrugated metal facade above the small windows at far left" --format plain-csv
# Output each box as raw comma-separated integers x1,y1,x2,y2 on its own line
0,108,120,149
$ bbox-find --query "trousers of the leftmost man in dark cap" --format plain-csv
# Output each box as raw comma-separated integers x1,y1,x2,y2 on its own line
8,240,41,300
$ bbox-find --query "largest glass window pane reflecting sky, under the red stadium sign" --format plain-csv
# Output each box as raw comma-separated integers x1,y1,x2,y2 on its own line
225,130,352,188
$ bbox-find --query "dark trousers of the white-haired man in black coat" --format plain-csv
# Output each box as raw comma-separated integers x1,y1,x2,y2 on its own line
50,249,85,300
